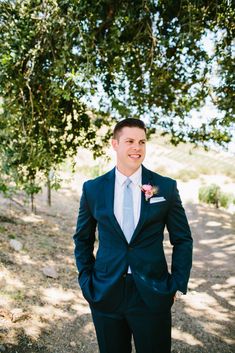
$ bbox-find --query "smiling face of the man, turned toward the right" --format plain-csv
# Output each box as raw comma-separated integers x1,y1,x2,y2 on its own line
112,127,146,176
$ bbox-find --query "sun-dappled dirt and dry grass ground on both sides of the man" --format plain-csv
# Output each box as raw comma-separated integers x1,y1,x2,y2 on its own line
0,188,235,353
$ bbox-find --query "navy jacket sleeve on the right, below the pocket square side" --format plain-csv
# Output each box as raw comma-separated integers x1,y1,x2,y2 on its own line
166,181,193,294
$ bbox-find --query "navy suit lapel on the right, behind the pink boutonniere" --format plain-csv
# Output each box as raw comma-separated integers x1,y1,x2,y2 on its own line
131,166,152,243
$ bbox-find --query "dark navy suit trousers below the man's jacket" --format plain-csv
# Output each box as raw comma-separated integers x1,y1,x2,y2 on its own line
91,274,171,353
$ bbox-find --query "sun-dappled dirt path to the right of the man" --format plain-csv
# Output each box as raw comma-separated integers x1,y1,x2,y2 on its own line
173,204,235,353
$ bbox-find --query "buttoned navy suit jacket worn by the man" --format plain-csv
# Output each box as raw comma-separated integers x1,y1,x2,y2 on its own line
74,166,192,312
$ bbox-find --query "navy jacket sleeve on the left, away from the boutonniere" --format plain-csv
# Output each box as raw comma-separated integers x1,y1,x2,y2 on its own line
73,183,96,286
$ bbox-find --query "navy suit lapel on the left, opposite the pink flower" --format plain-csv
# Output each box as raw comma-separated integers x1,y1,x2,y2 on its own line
104,168,126,241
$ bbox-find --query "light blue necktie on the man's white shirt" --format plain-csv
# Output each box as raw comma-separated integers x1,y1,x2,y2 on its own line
122,178,135,243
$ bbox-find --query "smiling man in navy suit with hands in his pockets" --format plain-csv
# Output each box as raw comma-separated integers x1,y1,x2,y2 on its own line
74,119,192,353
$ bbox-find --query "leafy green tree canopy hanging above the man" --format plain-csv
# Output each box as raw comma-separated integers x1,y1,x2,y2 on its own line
0,0,235,206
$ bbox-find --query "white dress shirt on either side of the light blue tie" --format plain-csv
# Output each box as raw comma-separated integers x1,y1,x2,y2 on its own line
114,166,142,236
